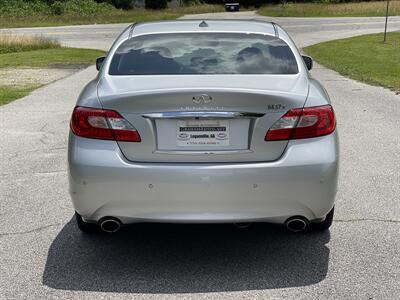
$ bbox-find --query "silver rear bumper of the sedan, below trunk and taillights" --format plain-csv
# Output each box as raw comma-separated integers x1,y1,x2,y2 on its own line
68,132,338,223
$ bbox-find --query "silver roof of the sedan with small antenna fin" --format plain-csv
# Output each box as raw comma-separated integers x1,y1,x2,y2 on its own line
128,19,280,38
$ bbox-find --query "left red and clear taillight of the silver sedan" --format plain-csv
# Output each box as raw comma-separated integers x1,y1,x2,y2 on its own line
71,106,141,142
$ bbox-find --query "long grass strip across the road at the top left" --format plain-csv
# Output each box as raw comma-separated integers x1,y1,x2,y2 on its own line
0,5,224,28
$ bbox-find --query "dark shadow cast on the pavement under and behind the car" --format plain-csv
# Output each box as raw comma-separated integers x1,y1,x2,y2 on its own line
43,220,330,294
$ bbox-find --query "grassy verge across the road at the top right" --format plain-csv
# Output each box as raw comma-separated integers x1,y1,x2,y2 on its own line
258,0,400,17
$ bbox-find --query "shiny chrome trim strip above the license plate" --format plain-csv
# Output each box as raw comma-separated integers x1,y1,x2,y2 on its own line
142,111,265,119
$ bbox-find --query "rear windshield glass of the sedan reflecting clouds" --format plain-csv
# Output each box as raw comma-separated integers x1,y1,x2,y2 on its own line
109,33,298,75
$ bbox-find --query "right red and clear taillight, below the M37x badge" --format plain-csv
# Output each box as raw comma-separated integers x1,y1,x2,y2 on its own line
265,105,336,141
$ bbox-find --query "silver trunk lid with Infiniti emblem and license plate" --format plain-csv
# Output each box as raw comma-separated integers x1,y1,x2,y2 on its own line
98,74,308,163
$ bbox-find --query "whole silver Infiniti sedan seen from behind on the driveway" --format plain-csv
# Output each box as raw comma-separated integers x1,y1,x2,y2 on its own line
68,20,339,232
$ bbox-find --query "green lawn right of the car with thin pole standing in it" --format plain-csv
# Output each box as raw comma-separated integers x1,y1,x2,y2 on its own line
303,32,400,91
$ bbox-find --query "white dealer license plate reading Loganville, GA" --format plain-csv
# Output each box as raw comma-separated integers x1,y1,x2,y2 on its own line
176,120,229,147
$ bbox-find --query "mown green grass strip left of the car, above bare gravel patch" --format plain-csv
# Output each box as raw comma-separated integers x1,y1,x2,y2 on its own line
0,48,104,68
